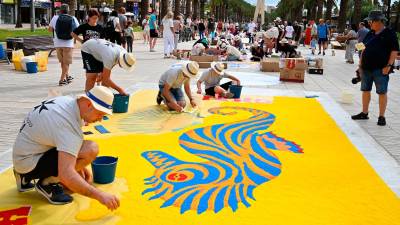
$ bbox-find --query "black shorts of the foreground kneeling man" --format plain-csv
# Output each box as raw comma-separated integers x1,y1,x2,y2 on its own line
22,148,58,180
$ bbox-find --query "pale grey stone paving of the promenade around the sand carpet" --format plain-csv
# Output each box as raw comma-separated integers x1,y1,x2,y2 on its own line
0,40,400,171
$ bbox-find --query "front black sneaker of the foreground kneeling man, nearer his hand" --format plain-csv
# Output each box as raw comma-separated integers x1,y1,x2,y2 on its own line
35,180,74,205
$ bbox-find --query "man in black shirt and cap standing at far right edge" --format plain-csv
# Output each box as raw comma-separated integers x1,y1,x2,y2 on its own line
351,10,399,126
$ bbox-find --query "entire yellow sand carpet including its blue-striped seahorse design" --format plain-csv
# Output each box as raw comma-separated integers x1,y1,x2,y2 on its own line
0,90,400,225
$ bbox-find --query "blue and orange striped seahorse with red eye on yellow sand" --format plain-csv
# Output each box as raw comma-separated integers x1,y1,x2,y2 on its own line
142,107,303,214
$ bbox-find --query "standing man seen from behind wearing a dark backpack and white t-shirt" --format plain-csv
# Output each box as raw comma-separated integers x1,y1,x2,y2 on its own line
48,4,79,86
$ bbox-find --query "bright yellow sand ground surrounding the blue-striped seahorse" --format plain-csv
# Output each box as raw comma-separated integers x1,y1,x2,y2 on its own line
0,91,400,225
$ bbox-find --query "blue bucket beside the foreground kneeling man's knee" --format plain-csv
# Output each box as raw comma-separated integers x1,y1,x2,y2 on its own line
92,156,118,184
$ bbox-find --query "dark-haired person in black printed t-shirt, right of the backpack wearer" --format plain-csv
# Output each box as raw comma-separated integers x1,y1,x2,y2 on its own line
72,9,104,43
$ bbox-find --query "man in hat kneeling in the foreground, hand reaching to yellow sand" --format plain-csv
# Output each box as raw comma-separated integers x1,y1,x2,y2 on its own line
13,86,120,210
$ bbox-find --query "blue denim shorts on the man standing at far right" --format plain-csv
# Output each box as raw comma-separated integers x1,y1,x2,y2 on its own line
361,69,389,95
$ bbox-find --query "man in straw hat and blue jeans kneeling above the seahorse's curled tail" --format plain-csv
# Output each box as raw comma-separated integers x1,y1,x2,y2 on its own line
157,61,199,112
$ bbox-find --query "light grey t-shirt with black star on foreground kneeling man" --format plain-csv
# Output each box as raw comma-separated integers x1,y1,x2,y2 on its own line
13,96,83,174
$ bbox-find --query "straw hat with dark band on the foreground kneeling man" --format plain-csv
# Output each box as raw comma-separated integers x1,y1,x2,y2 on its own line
77,86,114,115
